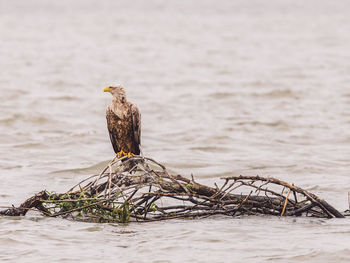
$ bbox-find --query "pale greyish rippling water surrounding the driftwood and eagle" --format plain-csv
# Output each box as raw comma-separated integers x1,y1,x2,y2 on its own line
0,0,350,262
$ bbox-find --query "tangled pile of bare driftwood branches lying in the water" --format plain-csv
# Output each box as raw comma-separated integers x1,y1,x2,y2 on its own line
0,156,344,222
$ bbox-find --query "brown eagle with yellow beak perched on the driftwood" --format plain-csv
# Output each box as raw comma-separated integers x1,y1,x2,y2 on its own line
103,85,141,157
